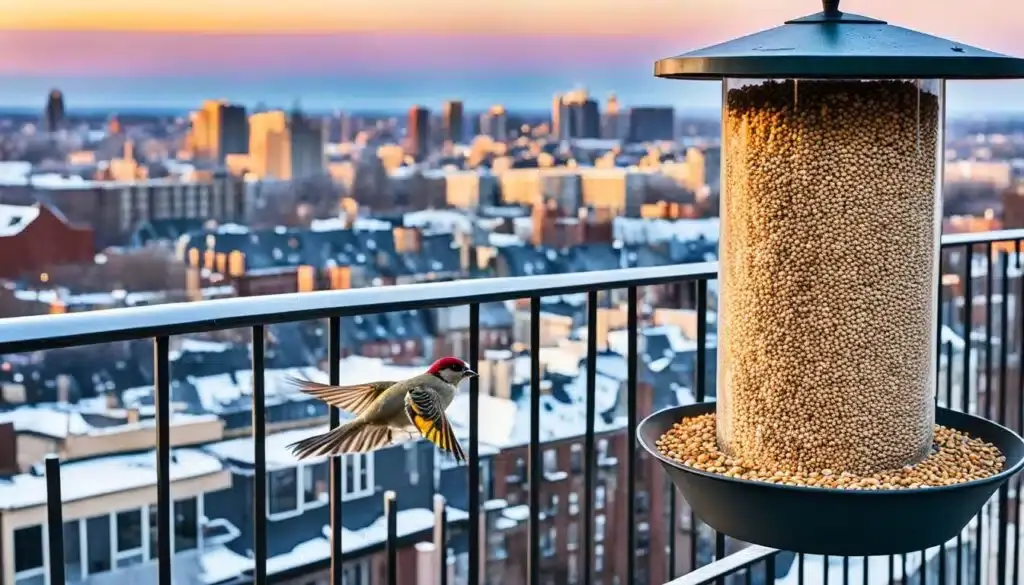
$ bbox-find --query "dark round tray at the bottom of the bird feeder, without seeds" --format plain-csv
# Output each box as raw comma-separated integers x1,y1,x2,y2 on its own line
637,403,1024,556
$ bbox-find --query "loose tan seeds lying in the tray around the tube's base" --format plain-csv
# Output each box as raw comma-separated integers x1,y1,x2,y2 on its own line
656,414,1006,490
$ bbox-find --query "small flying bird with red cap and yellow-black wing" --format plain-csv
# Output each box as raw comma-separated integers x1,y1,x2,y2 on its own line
288,357,477,463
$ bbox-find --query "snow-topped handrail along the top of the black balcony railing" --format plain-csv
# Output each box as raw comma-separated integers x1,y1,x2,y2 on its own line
0,229,1024,353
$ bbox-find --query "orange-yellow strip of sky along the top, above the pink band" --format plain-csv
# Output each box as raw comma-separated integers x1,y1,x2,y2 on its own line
0,0,1024,45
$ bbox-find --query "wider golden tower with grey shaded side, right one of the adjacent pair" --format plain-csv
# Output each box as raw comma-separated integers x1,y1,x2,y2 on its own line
249,110,324,180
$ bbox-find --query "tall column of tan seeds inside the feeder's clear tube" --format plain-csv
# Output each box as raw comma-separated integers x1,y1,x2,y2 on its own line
718,81,941,473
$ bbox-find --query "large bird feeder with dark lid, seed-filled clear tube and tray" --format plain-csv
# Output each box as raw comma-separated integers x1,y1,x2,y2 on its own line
639,0,1024,555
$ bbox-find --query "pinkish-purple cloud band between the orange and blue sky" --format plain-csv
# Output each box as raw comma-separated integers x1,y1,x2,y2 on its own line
0,31,696,77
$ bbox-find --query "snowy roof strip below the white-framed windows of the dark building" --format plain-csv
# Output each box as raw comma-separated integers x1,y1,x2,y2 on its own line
200,507,468,583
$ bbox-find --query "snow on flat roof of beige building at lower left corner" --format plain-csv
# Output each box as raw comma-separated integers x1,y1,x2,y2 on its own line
0,449,223,509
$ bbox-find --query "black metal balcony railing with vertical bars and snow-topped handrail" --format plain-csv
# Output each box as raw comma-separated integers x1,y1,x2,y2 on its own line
0,229,1024,585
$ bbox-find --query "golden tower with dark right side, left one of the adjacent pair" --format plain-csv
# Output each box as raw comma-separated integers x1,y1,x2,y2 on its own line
191,99,249,164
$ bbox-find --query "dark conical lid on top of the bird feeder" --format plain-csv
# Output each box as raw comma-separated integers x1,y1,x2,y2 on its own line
654,0,1024,80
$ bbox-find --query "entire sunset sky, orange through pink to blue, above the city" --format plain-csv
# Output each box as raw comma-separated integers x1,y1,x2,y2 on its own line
0,0,1024,112
